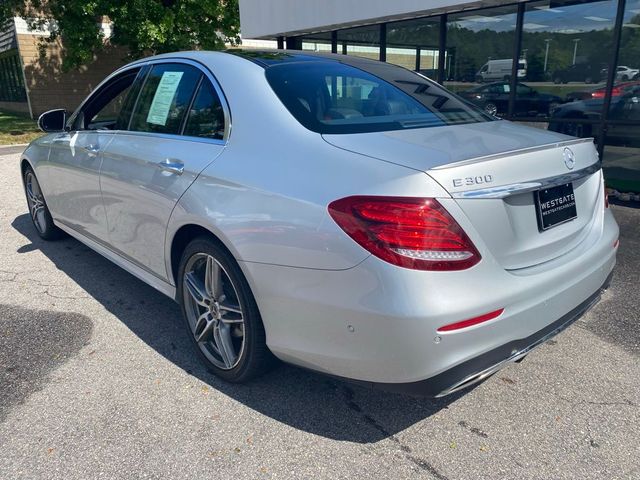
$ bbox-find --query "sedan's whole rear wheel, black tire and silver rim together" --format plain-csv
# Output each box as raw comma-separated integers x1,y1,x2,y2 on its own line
178,237,274,383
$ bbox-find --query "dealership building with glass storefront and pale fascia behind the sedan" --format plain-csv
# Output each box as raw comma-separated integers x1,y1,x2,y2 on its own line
240,0,640,192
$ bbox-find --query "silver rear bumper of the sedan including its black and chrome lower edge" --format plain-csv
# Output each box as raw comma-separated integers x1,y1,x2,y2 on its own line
240,211,618,395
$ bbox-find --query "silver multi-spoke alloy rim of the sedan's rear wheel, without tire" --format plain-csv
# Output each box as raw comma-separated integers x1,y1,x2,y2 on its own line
182,253,245,370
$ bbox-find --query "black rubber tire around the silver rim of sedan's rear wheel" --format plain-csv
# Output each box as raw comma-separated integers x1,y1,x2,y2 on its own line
176,236,276,383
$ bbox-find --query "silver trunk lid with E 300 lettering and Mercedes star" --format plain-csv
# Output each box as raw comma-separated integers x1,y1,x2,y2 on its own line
325,121,602,270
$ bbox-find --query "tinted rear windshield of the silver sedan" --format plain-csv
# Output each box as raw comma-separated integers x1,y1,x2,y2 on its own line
266,61,496,134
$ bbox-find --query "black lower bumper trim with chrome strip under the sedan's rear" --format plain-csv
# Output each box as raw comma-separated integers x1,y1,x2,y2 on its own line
357,272,613,397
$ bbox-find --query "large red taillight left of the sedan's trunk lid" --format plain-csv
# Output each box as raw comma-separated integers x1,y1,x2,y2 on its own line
329,196,481,270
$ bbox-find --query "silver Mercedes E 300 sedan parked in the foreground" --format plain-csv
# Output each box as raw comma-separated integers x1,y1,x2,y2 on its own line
21,50,618,396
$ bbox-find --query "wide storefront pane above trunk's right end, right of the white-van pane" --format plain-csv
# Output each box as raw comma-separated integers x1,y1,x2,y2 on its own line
513,0,617,124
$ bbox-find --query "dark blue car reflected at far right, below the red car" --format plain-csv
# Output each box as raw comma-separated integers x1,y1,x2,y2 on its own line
549,84,640,147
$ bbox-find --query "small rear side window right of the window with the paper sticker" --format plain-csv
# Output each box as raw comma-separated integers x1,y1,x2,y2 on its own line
184,78,225,140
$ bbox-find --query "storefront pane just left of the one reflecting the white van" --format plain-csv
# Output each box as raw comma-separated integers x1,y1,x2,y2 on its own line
387,17,440,80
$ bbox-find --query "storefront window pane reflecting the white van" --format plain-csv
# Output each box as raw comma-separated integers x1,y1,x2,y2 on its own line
445,5,526,112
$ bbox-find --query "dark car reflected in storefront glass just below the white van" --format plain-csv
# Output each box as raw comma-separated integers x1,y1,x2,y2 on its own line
459,82,562,117
